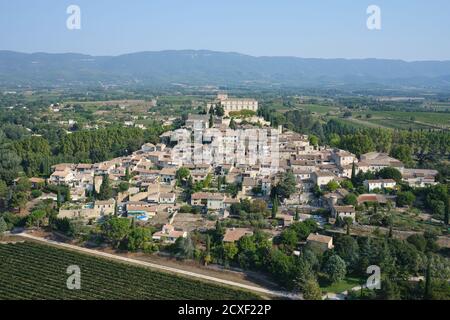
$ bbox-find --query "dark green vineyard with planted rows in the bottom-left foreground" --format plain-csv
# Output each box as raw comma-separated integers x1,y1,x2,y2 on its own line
0,242,259,300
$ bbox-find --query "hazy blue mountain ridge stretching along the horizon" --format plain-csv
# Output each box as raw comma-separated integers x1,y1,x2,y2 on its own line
0,50,450,88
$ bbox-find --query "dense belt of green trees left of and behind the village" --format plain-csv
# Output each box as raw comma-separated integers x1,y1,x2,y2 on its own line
0,125,165,183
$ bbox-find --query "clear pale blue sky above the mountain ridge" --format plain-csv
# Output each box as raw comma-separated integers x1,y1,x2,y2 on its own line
0,0,450,60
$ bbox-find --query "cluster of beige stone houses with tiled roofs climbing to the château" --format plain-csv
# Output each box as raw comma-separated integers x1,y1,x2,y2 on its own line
39,95,437,243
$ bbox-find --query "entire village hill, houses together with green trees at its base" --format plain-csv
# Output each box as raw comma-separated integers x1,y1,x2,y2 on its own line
4,93,449,299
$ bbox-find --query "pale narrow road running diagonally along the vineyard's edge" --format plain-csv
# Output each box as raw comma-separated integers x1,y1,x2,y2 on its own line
14,233,303,300
